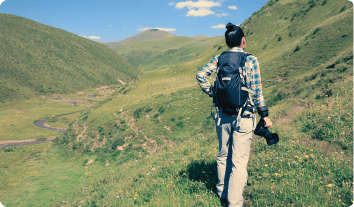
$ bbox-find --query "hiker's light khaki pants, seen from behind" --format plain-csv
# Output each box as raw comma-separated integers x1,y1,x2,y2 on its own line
216,114,254,207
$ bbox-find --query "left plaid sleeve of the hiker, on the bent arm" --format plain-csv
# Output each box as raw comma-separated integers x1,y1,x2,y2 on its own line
196,56,219,94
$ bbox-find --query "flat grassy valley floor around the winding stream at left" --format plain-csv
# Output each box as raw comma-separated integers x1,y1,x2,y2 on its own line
0,85,121,141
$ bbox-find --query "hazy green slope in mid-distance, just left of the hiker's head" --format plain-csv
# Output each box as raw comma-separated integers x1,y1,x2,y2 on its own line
114,36,224,71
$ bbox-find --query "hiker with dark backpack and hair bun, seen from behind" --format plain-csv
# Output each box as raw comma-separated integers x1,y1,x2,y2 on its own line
197,23,272,207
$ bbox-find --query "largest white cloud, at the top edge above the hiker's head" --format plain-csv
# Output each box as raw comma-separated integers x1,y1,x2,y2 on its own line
175,0,221,17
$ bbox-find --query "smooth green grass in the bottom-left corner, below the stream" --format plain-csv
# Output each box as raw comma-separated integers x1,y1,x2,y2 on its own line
0,144,108,206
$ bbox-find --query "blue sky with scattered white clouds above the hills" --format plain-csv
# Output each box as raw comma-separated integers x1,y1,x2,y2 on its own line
0,0,267,42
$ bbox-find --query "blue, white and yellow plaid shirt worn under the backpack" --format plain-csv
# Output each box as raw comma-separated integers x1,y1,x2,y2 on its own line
196,47,265,107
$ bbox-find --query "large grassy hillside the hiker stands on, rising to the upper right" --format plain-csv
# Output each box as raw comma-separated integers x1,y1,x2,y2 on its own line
0,0,354,206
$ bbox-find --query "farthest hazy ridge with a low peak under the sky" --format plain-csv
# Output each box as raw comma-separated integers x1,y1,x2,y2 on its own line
100,29,175,50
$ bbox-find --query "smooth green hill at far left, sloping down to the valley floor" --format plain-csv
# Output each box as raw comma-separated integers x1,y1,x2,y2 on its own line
0,14,140,102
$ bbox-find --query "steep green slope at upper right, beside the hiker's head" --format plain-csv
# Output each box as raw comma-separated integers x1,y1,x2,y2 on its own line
242,0,354,84
